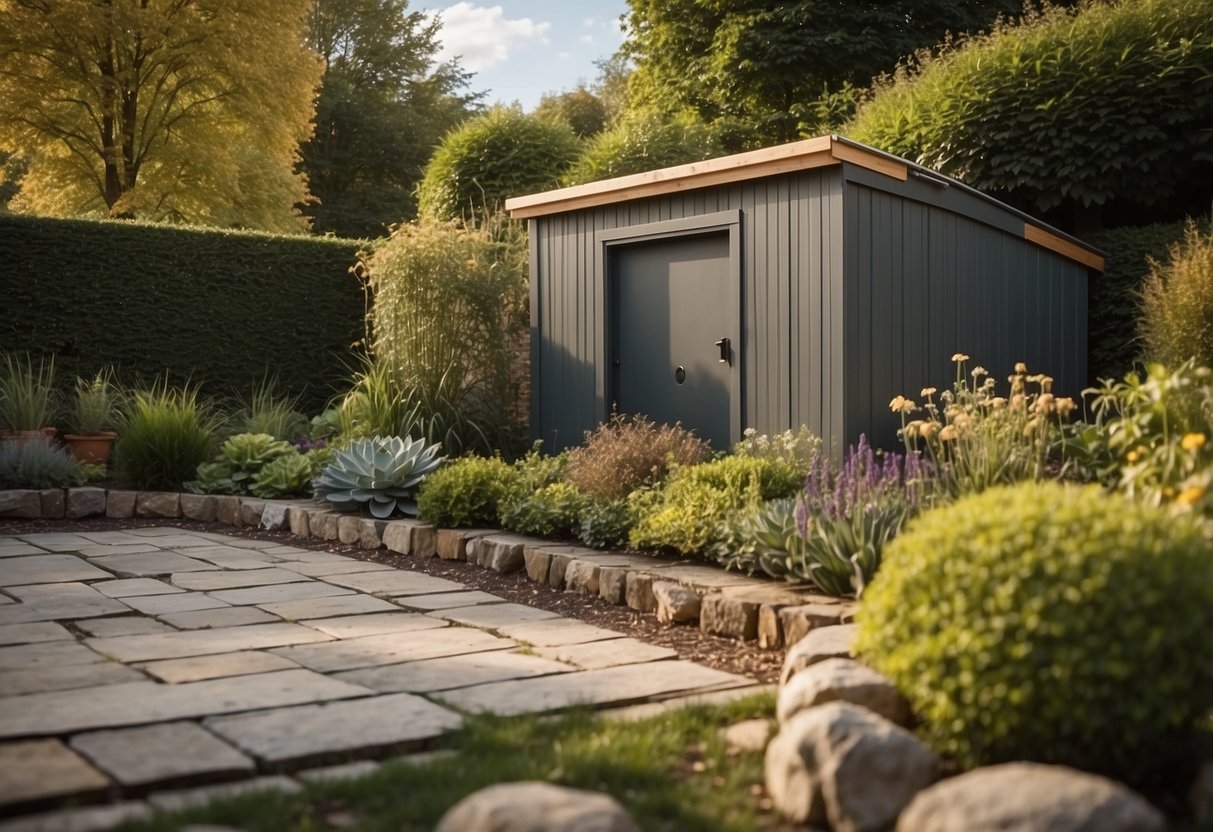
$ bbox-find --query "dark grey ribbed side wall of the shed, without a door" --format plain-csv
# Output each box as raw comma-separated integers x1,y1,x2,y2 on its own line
843,182,1087,448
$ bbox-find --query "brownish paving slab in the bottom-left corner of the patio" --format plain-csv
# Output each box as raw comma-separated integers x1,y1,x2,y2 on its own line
0,740,109,807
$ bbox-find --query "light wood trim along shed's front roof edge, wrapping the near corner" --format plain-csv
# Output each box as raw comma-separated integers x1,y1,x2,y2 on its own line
506,136,909,220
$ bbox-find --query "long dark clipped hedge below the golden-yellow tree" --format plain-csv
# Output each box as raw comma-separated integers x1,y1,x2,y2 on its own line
0,215,365,411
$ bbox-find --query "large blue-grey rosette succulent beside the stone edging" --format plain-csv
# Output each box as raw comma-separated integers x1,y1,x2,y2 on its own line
312,437,443,520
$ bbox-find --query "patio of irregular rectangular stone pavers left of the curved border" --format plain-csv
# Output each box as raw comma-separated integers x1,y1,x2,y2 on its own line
0,528,754,832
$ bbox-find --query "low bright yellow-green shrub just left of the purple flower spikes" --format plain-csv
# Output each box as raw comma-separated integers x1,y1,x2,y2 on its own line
628,456,801,554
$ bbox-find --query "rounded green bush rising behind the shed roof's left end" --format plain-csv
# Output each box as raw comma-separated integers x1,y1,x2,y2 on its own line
417,107,581,221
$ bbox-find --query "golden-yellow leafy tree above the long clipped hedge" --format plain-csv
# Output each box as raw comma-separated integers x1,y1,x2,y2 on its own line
0,0,320,230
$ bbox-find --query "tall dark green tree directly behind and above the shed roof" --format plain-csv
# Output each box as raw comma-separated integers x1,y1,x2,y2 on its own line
622,0,1074,146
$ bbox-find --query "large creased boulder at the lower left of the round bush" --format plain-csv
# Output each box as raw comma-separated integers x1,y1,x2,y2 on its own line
765,702,939,832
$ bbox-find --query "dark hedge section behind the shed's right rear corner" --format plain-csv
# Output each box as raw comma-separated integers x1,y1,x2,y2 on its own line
1084,218,1209,382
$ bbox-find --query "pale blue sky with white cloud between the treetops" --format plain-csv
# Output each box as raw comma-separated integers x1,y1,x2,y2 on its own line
412,0,627,110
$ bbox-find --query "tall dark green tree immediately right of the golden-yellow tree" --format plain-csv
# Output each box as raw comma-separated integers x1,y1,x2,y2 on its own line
303,0,479,237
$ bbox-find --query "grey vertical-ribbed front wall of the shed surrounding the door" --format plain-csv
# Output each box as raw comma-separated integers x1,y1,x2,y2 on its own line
530,167,843,450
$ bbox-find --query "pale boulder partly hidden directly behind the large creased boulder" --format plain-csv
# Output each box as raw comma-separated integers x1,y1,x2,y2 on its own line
776,659,910,725
